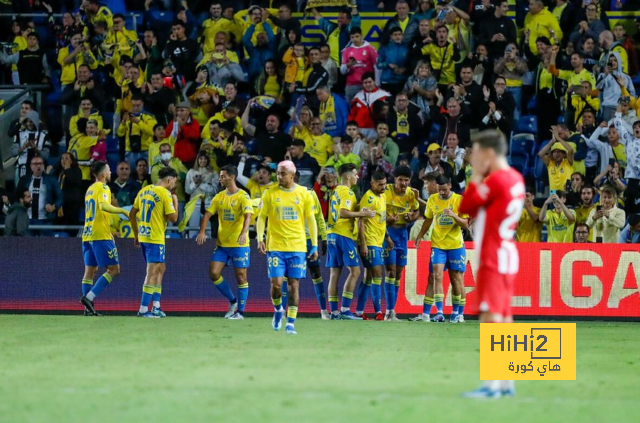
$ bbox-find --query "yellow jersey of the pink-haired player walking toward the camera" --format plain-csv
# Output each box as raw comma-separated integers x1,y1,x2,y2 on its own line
260,184,315,253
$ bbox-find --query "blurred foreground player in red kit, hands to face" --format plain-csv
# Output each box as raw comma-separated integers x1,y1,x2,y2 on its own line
460,130,525,398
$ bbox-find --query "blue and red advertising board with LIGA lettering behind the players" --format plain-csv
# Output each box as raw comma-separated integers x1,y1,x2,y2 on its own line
0,238,640,319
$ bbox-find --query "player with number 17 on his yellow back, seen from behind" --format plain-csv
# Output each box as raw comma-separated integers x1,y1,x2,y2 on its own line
129,167,178,318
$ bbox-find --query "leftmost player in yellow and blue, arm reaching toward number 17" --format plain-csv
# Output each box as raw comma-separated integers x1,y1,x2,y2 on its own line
80,162,128,316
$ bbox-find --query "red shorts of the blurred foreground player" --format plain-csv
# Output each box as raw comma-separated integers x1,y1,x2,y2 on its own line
471,267,516,318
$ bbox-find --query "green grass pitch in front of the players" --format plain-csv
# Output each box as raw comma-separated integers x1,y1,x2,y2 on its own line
0,315,640,423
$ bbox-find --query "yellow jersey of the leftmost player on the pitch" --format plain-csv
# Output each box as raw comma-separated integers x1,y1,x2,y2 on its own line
82,182,113,242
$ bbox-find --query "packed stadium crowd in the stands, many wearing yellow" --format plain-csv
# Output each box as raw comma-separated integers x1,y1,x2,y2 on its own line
0,0,640,243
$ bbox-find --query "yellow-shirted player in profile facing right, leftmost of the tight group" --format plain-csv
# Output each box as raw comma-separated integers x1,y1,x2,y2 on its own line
327,163,375,320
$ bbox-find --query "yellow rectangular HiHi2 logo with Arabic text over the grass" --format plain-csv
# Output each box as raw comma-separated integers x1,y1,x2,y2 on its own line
480,323,576,380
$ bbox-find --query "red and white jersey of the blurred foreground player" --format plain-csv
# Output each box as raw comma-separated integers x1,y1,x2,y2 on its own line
460,168,525,275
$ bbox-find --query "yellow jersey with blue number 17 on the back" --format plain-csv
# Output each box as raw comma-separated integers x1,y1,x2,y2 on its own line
133,185,176,245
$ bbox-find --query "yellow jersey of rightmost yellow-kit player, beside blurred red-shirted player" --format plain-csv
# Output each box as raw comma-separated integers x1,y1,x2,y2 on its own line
424,192,468,250
